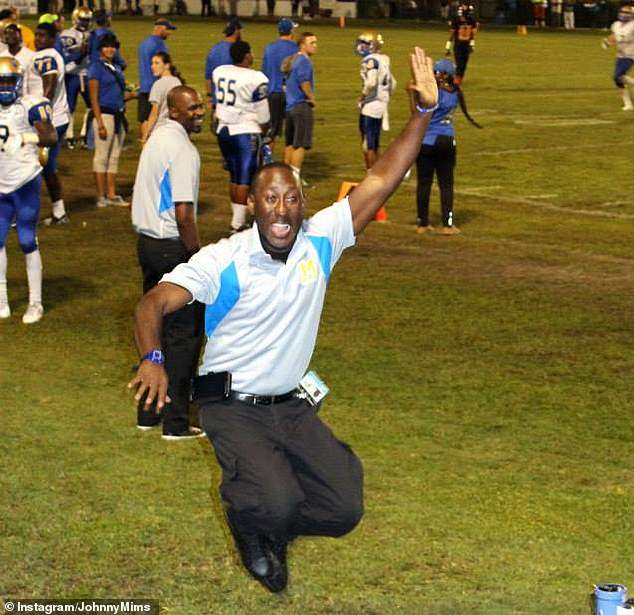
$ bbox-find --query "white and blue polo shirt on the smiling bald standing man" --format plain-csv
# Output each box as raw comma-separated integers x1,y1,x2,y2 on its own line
132,119,200,239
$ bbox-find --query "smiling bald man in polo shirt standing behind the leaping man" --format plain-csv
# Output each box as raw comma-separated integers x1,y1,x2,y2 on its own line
132,86,204,440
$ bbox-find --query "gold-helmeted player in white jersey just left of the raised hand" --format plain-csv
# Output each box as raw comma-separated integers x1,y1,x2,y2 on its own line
355,32,396,169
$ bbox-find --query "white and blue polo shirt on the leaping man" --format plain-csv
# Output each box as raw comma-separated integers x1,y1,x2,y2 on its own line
161,198,355,395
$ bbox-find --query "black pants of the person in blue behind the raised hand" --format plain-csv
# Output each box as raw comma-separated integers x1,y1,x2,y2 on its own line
416,136,456,226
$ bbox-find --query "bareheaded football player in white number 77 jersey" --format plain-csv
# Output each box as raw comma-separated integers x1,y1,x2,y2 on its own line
29,23,69,225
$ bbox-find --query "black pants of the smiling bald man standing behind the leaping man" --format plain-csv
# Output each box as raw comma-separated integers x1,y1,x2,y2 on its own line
137,234,205,433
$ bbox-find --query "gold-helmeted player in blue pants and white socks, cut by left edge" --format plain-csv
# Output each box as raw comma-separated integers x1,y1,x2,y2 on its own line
0,57,57,324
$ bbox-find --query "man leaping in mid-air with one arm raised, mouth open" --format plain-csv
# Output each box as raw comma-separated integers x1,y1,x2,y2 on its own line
129,48,438,592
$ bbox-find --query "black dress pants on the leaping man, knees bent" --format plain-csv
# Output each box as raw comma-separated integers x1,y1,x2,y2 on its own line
198,397,363,540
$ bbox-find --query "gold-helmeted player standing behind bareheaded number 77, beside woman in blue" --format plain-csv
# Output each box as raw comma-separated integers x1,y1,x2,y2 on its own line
60,6,92,149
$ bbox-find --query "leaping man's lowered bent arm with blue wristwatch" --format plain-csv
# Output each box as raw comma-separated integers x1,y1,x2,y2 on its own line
128,282,192,411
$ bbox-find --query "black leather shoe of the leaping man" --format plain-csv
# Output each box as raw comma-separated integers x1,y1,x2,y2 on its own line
225,511,286,593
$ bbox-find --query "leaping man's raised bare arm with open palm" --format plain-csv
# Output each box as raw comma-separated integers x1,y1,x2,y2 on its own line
349,47,438,235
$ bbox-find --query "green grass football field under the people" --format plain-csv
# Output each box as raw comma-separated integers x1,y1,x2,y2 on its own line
0,20,634,615
